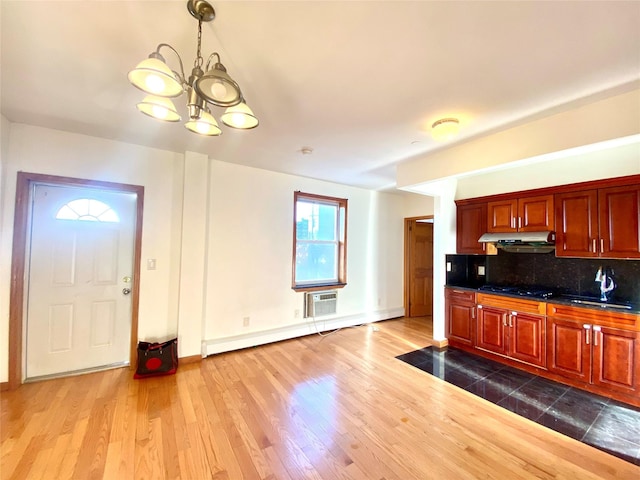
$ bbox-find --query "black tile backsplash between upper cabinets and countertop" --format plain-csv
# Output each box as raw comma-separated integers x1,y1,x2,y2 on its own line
446,250,640,303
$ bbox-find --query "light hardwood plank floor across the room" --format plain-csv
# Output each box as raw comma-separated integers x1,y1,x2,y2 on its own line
0,319,640,480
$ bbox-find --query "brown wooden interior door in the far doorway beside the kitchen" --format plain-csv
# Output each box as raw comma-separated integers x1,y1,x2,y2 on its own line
405,220,433,317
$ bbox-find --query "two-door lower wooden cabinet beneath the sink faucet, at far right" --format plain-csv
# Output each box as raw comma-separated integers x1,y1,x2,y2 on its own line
547,304,640,400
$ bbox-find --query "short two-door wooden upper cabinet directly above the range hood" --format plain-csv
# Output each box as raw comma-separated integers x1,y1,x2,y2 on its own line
487,195,554,233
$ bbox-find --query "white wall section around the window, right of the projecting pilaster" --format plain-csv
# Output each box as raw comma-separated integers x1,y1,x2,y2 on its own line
205,161,404,353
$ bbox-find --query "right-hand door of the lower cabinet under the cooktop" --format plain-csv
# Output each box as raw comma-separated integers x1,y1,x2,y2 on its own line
508,312,546,367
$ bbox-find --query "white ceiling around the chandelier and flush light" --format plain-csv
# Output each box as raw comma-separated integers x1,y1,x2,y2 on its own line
1,0,640,189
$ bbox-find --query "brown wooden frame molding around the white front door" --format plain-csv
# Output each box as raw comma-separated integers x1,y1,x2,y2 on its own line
9,172,144,389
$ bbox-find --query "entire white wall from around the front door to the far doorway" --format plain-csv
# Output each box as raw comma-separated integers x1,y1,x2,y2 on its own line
0,119,410,382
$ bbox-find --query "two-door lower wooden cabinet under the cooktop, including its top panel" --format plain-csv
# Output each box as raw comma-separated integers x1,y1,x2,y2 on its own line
475,293,546,367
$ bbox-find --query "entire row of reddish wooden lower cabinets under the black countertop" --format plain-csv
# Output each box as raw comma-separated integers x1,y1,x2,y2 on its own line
445,287,640,407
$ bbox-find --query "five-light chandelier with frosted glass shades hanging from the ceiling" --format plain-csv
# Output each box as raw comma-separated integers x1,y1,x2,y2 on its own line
128,0,258,136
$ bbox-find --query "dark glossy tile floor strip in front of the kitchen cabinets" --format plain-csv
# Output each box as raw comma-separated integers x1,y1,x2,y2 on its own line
397,347,640,465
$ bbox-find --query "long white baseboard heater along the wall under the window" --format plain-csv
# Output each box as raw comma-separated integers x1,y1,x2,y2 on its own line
202,307,404,357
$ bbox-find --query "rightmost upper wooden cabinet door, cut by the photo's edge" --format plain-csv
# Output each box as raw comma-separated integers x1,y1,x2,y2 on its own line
598,185,640,258
